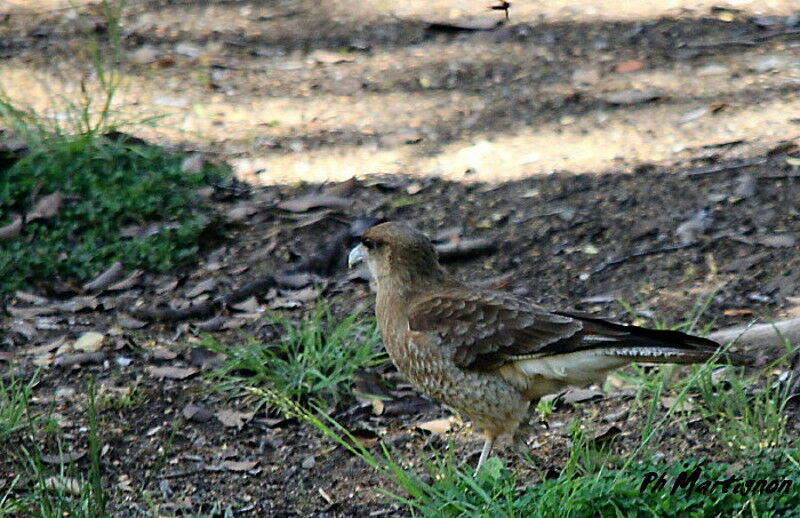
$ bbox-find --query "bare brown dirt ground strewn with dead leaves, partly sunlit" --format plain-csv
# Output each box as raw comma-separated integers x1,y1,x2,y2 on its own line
0,0,800,516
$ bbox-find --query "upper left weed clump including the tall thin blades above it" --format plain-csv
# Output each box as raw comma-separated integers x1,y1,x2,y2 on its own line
0,1,227,294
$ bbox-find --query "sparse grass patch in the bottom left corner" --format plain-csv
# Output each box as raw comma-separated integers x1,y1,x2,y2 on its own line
0,380,110,518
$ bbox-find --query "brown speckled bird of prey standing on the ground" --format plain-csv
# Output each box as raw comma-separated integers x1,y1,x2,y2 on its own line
349,222,746,469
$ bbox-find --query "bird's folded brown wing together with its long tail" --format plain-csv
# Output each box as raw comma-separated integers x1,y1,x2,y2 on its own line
408,289,747,370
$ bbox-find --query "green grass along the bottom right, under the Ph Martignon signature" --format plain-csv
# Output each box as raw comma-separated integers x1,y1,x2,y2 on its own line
258,298,800,517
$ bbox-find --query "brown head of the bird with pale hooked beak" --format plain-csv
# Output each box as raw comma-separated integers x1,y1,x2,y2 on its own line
348,221,445,290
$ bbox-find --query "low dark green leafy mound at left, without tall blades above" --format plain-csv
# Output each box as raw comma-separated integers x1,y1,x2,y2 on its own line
0,135,225,292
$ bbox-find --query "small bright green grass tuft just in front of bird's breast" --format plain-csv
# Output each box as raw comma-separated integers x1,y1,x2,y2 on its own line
201,304,383,416
